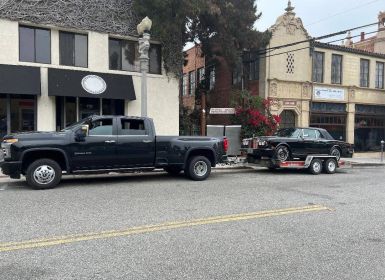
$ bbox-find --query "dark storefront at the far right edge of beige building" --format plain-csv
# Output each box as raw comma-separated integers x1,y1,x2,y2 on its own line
354,105,385,152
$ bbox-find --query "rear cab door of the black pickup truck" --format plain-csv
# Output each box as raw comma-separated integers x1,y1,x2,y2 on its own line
117,117,155,168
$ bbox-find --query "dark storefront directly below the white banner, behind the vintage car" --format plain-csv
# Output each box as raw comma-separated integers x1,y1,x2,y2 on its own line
310,102,347,141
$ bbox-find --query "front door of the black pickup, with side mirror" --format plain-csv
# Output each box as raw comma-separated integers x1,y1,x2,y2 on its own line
70,118,118,170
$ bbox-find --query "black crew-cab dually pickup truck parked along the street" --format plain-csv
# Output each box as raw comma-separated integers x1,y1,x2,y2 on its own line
0,116,228,189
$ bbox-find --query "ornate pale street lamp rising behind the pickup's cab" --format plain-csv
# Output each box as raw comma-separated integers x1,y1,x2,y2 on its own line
137,17,152,117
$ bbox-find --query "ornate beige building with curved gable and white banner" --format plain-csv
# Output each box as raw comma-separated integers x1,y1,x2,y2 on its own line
259,1,385,151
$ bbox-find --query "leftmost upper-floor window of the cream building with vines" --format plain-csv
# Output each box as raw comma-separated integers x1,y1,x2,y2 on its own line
19,26,51,63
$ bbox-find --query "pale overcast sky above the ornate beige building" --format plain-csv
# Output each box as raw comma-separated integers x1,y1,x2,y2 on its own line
255,0,385,40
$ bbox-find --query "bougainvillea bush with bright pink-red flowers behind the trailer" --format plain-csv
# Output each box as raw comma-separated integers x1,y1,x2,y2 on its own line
232,90,281,138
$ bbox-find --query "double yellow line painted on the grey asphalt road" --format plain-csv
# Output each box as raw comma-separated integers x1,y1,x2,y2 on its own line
0,205,331,252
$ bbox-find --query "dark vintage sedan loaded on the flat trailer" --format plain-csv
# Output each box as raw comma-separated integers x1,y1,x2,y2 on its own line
242,127,353,162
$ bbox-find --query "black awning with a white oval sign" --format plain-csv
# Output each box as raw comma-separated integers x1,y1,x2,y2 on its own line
48,68,136,100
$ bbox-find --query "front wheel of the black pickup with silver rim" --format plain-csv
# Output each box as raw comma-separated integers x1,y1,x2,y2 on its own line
26,158,62,190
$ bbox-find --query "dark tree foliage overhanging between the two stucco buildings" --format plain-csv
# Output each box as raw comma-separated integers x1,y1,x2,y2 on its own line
134,0,270,75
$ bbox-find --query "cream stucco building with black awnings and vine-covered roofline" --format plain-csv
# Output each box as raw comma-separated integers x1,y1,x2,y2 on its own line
0,0,179,138
